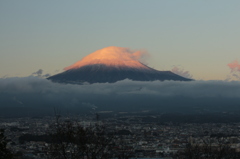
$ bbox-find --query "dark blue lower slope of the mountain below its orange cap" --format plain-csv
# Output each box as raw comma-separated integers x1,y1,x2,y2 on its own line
48,65,190,84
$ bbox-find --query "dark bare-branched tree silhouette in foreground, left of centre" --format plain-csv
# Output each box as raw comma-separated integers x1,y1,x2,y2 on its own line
47,116,132,159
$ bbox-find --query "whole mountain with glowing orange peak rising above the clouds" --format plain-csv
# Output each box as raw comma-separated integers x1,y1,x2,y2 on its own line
48,46,191,84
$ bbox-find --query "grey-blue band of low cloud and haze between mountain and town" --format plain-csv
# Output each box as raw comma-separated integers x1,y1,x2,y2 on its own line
0,76,240,115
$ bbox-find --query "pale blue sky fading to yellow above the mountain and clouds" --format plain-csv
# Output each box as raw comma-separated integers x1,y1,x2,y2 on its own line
0,0,240,80
